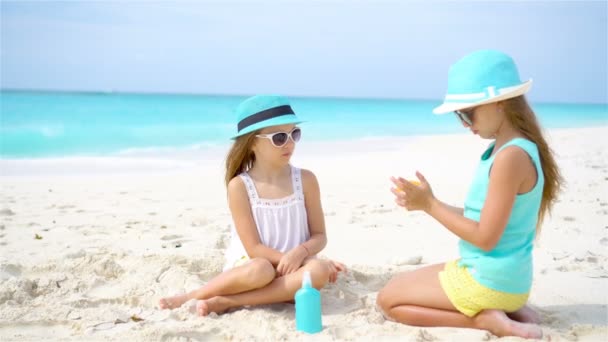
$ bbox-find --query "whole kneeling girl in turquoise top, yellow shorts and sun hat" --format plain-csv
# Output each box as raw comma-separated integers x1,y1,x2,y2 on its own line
377,50,562,338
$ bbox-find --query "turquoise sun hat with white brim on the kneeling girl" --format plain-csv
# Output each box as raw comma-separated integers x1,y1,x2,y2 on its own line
433,50,532,114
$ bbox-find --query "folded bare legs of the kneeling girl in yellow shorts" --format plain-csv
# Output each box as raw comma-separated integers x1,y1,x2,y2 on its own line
377,264,542,338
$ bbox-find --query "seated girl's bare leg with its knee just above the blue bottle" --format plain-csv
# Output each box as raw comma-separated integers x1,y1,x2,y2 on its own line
197,259,329,316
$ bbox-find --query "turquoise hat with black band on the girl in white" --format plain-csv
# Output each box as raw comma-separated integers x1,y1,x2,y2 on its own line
232,95,303,139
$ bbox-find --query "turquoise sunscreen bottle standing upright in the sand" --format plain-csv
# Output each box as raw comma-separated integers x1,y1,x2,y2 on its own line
295,271,323,334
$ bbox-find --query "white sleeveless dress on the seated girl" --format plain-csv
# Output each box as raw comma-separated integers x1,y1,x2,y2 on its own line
224,165,310,271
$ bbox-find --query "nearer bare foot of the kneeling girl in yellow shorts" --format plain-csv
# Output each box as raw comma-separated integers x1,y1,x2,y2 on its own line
475,310,543,339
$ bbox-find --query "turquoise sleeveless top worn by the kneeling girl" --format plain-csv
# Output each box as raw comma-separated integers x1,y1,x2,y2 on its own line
459,138,545,294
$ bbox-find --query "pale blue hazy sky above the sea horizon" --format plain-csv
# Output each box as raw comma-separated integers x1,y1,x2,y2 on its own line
0,0,608,103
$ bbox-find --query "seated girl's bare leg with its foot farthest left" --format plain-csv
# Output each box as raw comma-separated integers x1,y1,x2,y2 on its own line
159,258,275,309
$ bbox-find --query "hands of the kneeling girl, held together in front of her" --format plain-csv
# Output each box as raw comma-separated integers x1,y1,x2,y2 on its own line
391,171,435,211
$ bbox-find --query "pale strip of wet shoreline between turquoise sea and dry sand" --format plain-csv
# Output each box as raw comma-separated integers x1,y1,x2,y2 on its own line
0,125,608,180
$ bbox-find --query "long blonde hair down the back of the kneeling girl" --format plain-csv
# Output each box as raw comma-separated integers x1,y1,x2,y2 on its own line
503,95,564,231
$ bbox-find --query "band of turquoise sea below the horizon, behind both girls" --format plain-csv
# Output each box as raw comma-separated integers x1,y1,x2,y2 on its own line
0,91,608,159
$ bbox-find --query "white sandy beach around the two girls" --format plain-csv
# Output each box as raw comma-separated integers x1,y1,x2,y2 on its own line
0,127,608,341
